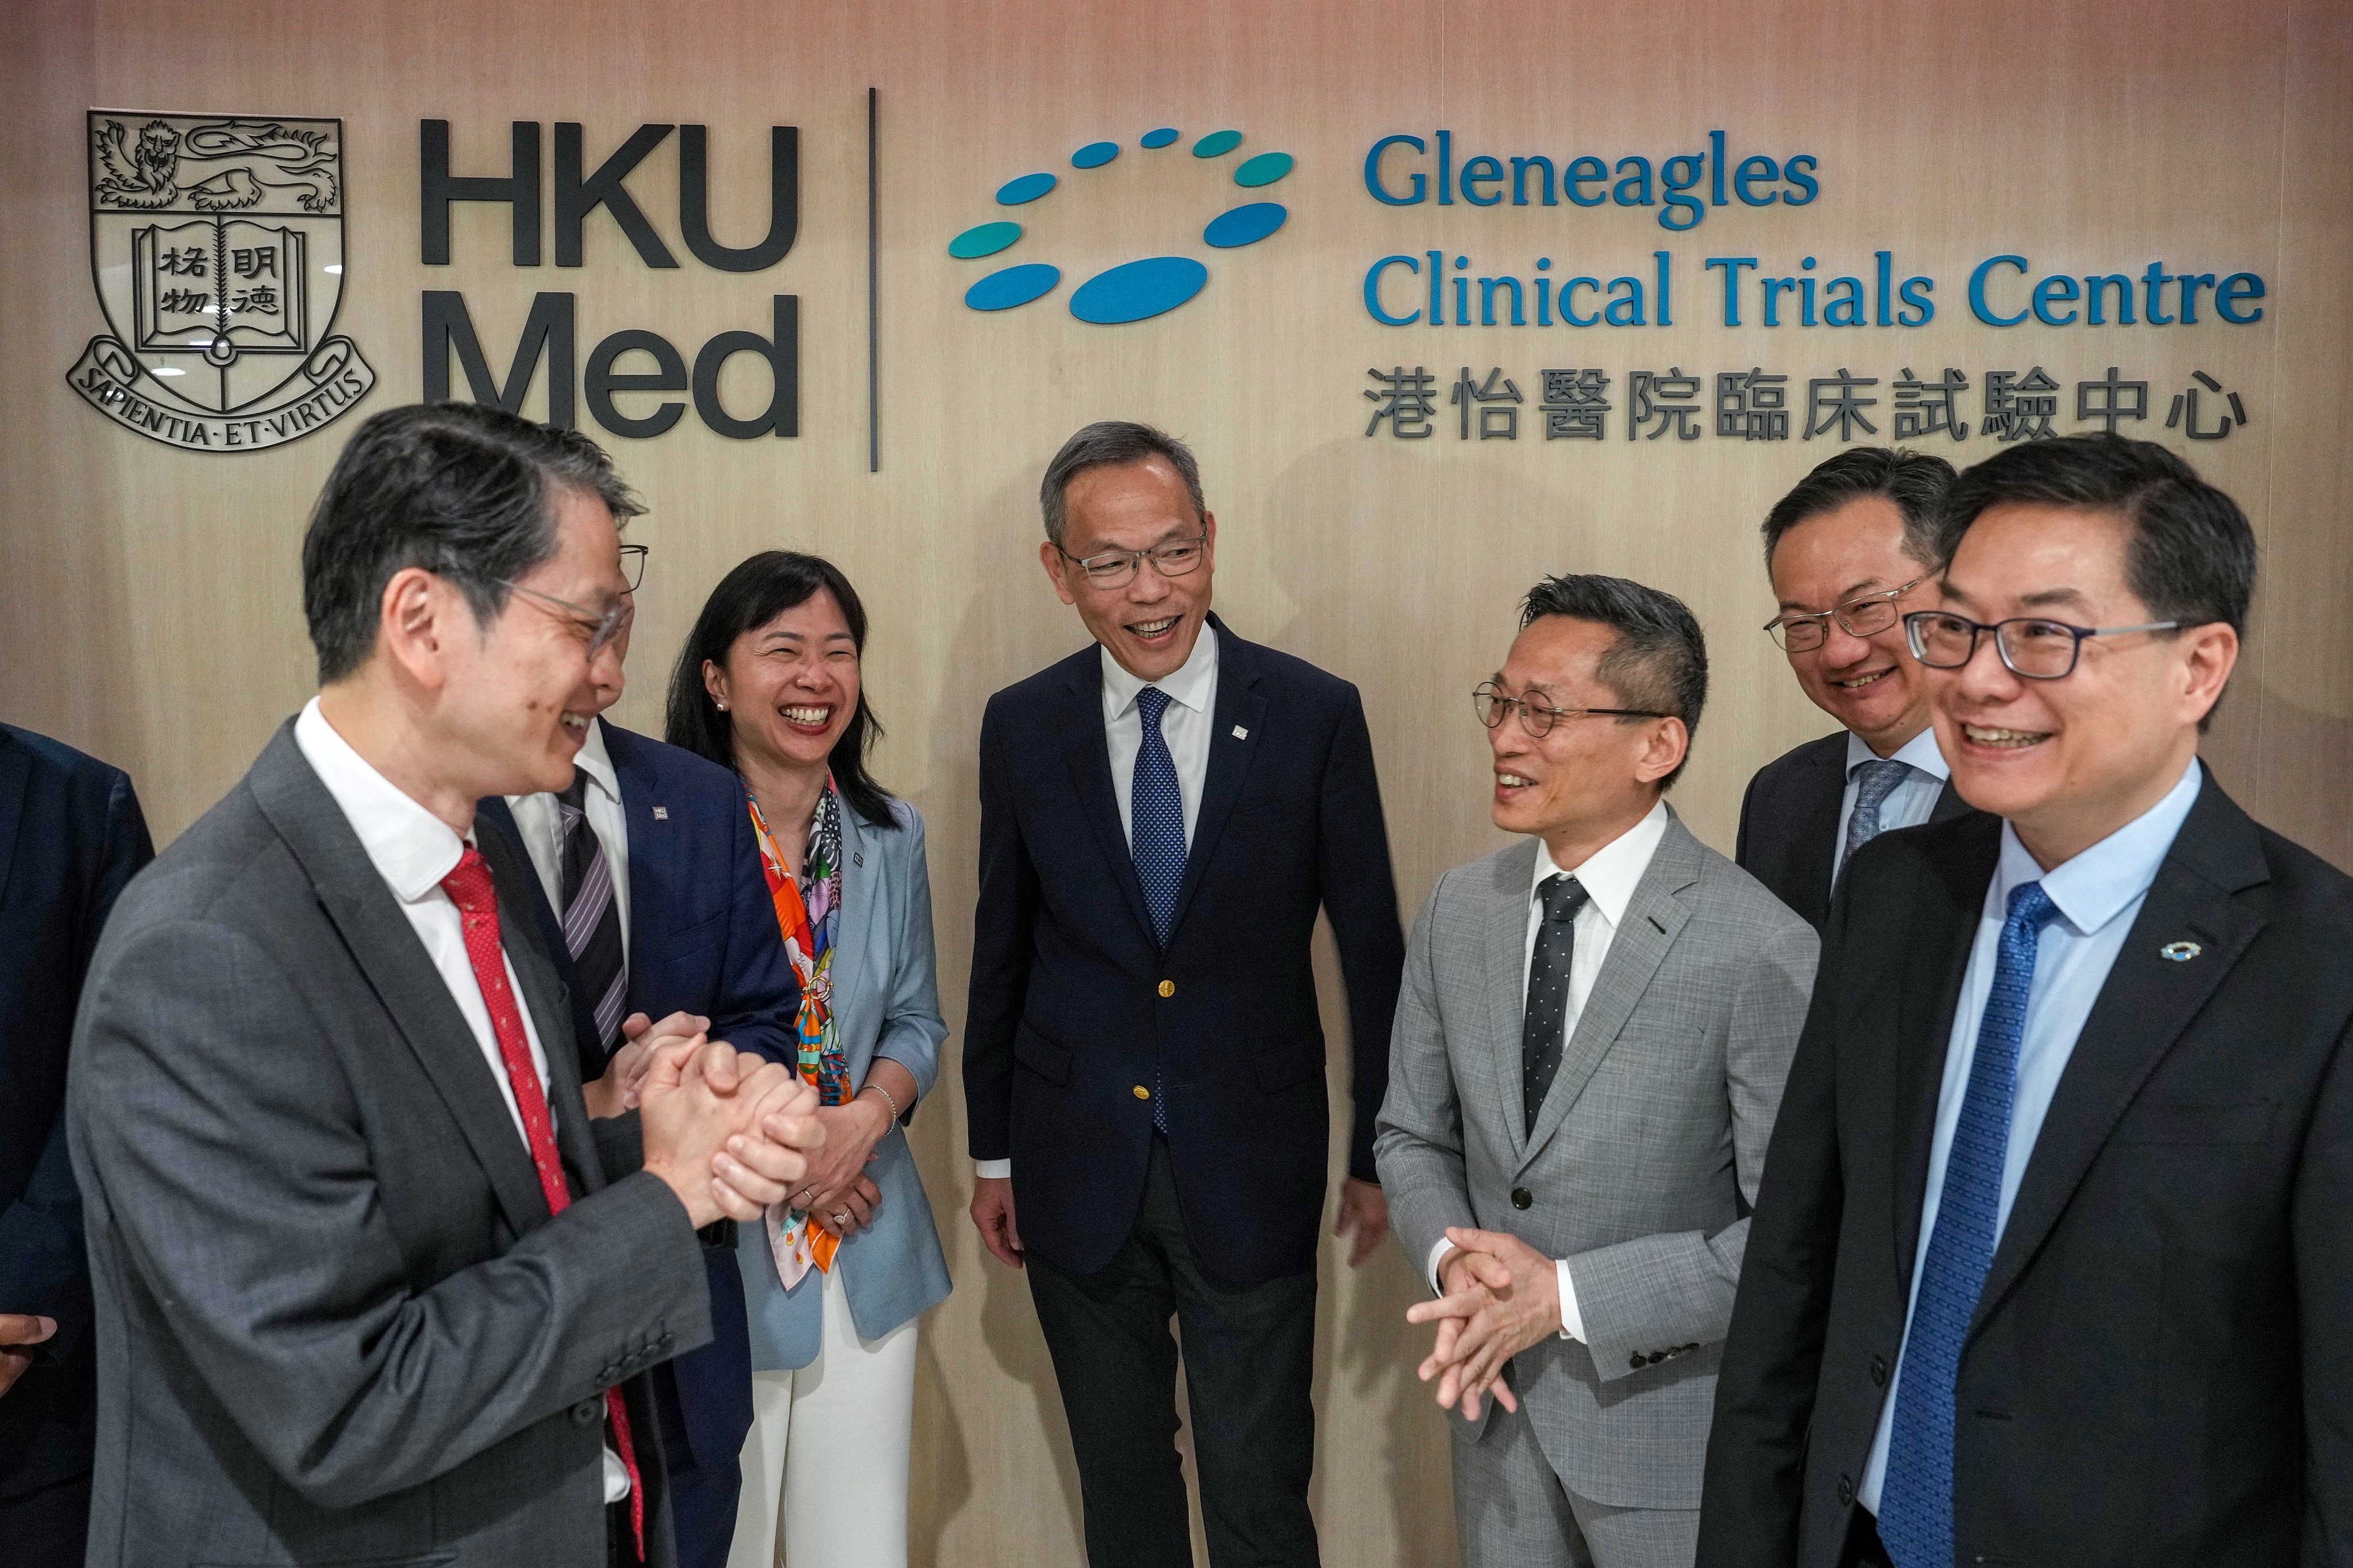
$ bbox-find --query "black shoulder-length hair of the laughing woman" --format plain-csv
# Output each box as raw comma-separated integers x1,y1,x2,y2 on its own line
664,551,899,829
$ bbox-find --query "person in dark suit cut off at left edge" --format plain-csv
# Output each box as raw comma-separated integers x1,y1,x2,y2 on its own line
0,725,155,1563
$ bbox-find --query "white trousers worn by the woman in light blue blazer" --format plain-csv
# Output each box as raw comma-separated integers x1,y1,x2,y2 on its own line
727,1269,915,1568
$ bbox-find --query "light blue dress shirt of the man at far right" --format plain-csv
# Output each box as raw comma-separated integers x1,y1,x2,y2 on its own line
1854,758,2205,1514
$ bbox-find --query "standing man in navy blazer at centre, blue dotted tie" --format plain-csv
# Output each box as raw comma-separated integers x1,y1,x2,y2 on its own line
965,421,1405,1568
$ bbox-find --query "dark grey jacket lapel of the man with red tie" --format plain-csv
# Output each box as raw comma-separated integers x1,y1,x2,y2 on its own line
247,721,560,1236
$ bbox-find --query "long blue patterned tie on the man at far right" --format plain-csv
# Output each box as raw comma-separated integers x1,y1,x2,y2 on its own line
1880,883,2059,1568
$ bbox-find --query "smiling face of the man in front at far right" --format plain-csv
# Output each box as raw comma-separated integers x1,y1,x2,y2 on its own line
1927,504,2238,869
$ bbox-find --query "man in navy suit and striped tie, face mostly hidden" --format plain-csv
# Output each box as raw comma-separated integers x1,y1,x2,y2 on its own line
480,586,800,1568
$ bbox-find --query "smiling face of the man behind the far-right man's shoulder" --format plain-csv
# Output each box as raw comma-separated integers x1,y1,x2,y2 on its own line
1772,494,1930,756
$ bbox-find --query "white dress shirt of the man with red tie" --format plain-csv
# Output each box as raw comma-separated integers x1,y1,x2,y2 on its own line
294,697,628,1502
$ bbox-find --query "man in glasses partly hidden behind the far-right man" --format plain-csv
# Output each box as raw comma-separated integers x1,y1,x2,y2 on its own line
1732,448,1970,930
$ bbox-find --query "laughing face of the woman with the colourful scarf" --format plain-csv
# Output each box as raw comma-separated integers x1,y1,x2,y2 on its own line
703,588,859,770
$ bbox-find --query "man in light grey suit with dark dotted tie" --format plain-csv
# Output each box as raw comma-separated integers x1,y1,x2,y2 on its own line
1374,577,1816,1568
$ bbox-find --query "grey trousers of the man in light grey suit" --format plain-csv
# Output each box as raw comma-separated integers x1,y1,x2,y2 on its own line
1454,1408,1699,1568
